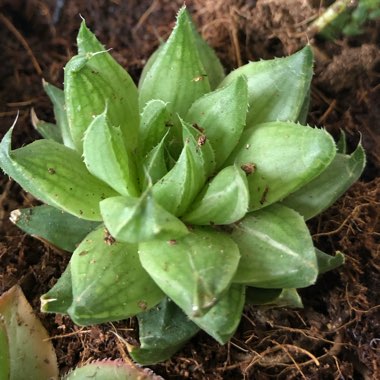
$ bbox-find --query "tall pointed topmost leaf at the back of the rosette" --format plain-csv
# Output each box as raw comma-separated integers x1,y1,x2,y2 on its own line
139,7,210,142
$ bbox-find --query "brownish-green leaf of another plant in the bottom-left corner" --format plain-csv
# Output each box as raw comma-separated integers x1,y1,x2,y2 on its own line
0,285,58,379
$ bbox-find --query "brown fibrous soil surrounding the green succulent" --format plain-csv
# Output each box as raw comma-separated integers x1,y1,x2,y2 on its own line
0,0,380,380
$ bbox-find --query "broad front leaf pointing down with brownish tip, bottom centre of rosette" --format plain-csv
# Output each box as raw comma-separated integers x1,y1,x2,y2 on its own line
139,227,240,316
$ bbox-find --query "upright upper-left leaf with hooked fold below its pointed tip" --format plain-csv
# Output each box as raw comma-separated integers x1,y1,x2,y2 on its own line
65,22,139,152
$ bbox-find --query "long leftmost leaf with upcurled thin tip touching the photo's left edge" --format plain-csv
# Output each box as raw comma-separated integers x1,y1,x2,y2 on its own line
0,127,115,220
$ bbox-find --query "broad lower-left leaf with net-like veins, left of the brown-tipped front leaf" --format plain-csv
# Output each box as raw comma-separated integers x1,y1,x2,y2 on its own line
68,229,163,325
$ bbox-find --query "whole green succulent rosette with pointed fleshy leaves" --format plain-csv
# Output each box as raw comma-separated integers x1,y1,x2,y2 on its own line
0,7,365,364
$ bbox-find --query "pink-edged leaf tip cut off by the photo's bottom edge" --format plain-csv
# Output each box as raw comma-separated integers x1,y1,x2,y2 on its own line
62,360,163,380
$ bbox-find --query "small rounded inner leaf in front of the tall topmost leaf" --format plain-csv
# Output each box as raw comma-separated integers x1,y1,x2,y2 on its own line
139,100,173,156
